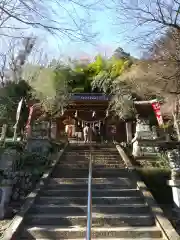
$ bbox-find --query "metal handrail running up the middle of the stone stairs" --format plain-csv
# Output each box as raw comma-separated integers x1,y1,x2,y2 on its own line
86,143,92,240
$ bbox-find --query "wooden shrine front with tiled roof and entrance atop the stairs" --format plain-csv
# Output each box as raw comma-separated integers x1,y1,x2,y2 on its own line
54,94,126,142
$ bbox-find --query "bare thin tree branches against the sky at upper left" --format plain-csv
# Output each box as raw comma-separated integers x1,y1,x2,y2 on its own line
0,0,101,41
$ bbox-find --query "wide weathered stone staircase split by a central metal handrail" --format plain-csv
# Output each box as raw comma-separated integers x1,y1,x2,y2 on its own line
17,145,163,240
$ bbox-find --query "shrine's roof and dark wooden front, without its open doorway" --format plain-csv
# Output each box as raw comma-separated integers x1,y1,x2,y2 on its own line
54,93,126,141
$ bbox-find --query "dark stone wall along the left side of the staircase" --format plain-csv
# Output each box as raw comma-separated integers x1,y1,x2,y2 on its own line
0,139,60,219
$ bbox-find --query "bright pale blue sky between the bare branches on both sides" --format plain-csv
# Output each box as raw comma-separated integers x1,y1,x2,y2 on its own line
0,0,141,61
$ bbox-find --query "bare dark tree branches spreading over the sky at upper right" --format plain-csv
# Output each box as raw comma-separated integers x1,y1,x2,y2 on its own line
111,0,180,47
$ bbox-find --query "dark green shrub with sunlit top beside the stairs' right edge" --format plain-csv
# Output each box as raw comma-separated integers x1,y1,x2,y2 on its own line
137,168,173,204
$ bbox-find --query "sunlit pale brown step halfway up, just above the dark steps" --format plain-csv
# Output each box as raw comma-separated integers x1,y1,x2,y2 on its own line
49,177,134,186
